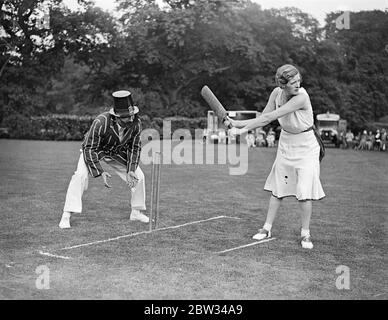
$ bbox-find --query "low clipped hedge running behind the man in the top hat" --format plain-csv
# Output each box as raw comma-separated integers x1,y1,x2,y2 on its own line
2,114,207,141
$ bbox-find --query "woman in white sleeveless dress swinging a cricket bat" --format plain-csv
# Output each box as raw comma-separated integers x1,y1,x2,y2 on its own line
228,64,325,249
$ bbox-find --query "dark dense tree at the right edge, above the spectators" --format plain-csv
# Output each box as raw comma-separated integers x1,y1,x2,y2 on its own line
325,10,388,128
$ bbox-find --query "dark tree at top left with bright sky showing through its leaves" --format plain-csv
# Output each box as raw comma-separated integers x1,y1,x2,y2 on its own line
0,0,115,120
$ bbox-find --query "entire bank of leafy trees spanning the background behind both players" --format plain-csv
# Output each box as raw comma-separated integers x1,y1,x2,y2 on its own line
0,0,388,130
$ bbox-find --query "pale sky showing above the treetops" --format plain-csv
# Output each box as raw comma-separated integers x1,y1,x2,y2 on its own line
65,0,388,25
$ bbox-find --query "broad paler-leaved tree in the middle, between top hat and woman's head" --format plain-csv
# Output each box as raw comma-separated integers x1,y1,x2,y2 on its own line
98,0,261,115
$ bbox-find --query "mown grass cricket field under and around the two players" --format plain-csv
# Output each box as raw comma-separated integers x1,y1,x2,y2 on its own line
0,140,388,300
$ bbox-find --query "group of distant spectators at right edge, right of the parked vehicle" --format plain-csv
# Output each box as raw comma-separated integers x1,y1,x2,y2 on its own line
340,128,387,151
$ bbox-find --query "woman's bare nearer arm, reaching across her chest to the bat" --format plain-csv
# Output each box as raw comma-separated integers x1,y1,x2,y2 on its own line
236,94,308,133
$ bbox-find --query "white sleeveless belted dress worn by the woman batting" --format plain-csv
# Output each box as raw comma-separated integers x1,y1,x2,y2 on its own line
264,88,325,200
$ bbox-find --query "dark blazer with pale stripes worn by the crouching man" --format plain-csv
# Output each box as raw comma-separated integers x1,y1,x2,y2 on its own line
82,112,141,178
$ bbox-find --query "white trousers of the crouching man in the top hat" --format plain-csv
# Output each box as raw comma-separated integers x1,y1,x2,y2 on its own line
63,152,146,213
